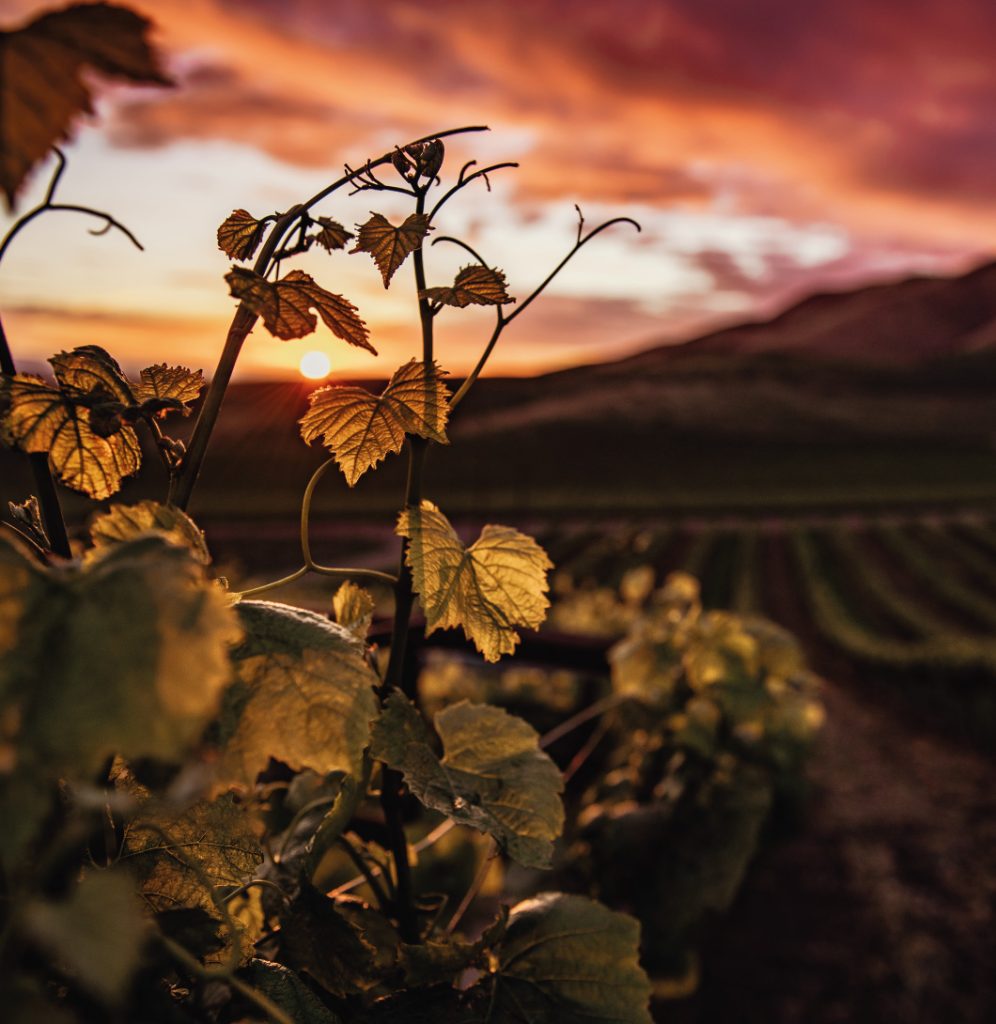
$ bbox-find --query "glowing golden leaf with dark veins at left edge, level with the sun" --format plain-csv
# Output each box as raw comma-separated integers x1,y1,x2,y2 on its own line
4,345,141,501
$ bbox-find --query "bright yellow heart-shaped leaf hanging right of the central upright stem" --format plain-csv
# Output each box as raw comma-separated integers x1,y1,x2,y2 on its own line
395,501,553,662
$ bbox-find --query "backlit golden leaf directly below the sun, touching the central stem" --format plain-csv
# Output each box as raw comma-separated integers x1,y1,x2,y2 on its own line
301,359,449,486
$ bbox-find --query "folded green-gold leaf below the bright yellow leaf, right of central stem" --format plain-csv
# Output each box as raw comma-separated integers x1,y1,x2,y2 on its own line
371,691,564,867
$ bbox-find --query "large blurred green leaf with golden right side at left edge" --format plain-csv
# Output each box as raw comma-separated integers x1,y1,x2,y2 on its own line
0,537,241,853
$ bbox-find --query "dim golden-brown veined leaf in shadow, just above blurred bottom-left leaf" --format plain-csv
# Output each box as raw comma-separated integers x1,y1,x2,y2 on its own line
121,795,263,954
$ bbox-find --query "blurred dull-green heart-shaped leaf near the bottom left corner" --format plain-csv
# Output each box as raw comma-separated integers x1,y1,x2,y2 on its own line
23,870,147,1006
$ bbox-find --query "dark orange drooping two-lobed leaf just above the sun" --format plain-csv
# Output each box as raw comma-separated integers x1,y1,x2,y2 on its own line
225,266,377,355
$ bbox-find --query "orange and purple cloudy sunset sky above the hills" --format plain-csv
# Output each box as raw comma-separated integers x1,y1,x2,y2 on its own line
0,0,996,377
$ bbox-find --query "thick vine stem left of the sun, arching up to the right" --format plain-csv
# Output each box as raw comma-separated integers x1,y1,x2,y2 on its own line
173,125,487,511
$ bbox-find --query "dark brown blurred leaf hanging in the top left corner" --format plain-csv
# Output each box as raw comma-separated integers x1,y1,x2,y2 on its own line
0,3,169,209
